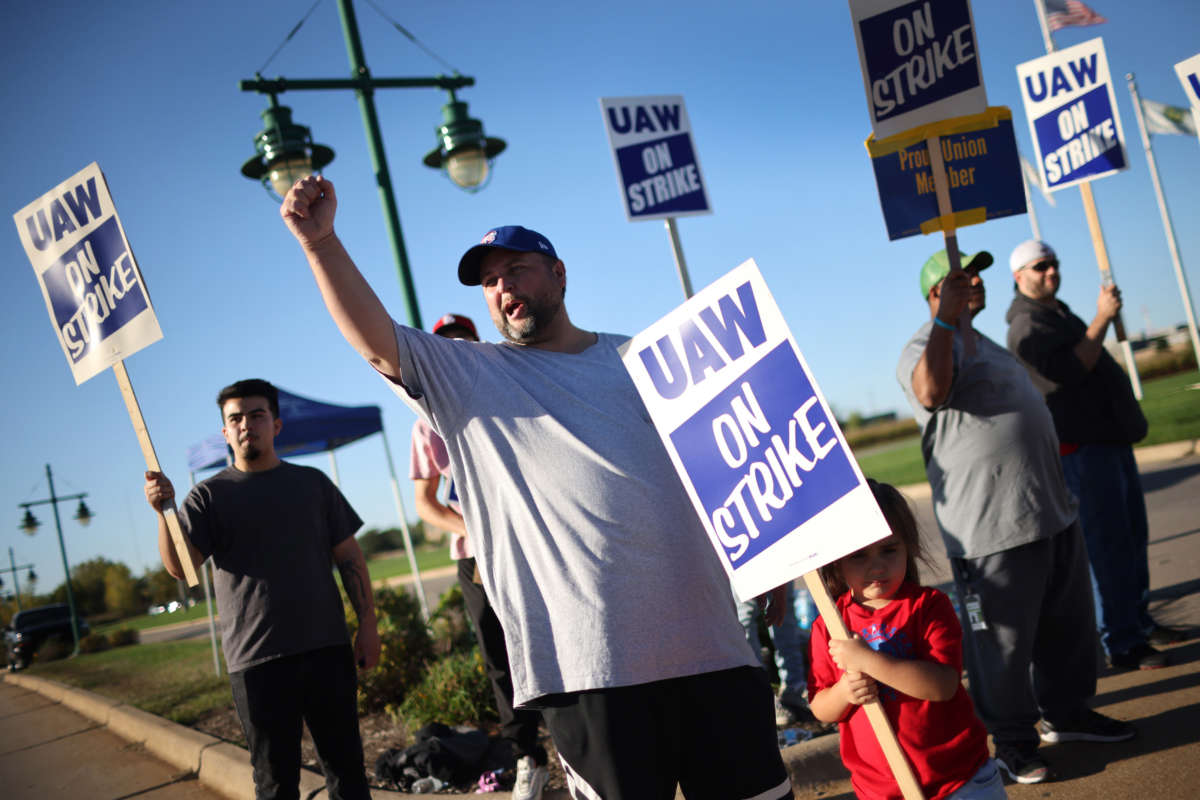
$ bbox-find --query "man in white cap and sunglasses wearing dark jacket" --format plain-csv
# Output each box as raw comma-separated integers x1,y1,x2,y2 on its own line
1006,240,1177,669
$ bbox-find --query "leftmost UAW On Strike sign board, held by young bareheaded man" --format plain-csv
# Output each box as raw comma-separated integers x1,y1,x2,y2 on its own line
13,162,162,384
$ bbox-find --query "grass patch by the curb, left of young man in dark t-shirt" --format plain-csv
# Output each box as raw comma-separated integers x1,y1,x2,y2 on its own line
29,640,233,724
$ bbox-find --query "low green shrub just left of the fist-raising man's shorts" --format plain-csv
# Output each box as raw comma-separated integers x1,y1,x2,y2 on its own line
398,648,497,730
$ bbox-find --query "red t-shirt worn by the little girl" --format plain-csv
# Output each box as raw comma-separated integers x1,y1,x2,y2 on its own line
809,583,988,800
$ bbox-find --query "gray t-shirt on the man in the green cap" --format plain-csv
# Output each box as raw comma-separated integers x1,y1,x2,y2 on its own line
896,320,1076,558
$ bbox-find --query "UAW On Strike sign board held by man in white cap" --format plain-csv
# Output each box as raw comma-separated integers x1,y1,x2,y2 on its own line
1016,38,1129,192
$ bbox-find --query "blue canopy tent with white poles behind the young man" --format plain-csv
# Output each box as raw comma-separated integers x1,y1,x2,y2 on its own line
187,389,430,674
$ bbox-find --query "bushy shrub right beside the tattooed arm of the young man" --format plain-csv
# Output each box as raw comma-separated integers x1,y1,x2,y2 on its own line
346,589,433,712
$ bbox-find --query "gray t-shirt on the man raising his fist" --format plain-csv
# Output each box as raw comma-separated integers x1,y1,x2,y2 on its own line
392,325,757,705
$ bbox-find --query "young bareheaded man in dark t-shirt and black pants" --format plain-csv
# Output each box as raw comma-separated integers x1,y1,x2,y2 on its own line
145,379,379,800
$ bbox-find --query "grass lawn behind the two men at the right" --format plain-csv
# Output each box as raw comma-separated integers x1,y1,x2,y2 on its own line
854,369,1200,486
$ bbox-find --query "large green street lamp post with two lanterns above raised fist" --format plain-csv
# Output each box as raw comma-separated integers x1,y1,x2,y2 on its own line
238,0,505,327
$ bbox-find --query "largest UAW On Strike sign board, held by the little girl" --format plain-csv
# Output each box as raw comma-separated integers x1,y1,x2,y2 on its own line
622,260,889,600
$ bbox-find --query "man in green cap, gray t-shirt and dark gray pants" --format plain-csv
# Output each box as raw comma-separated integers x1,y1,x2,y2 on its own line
896,251,1134,783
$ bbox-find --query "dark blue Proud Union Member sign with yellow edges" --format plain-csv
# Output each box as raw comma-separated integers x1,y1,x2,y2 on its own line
866,107,1026,240
